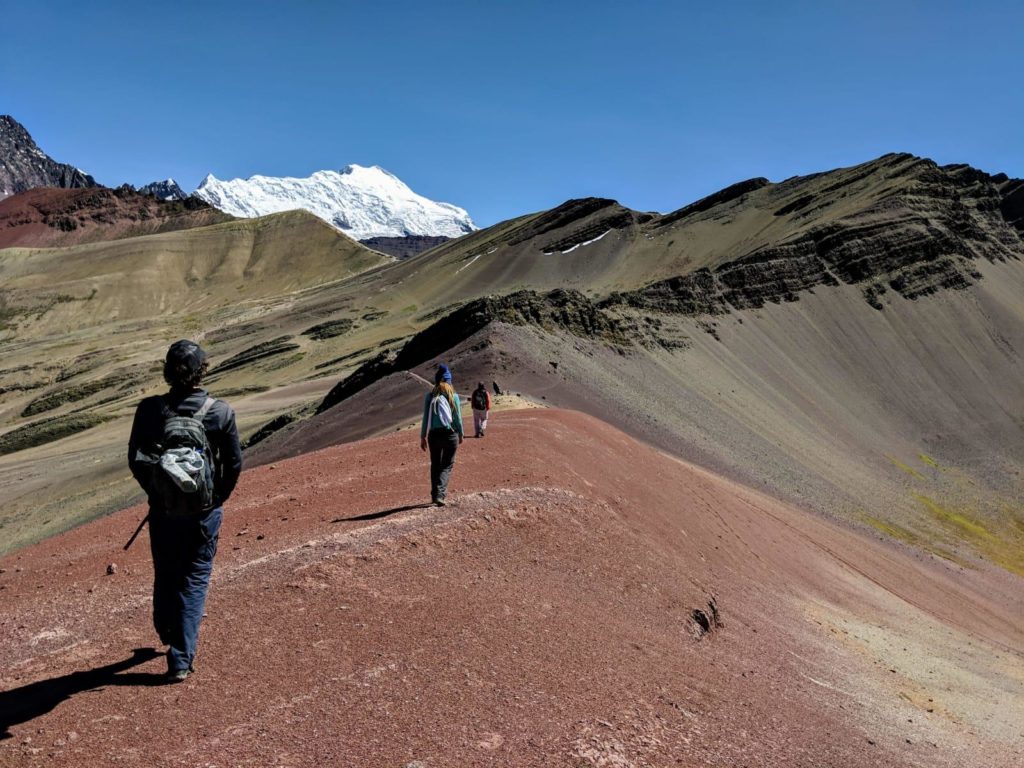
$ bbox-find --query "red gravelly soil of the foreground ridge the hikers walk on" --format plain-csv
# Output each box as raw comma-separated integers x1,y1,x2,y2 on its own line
0,410,1024,767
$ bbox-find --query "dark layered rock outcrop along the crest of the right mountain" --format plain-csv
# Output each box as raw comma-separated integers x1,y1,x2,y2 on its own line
604,155,1024,315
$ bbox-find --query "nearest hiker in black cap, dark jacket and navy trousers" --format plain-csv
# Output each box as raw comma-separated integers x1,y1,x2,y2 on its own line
128,339,242,682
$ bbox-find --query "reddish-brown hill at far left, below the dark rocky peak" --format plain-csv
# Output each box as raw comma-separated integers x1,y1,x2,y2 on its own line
0,187,232,249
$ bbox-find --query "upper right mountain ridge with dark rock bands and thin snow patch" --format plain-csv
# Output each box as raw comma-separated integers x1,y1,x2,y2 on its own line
331,155,1024,313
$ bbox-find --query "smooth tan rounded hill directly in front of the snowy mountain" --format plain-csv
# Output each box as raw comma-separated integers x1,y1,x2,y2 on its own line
0,211,391,340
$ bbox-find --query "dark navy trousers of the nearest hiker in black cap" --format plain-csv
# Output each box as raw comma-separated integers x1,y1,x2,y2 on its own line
150,507,223,672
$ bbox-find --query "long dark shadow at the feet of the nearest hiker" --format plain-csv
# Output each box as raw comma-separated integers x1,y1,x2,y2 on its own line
0,648,167,740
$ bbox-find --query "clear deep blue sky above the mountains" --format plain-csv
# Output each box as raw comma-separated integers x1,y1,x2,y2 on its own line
0,0,1024,225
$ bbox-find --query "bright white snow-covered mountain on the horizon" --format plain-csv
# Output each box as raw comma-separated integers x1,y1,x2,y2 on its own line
195,165,477,240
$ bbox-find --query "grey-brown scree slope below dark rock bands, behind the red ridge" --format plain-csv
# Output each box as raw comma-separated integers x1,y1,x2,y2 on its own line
253,246,1024,574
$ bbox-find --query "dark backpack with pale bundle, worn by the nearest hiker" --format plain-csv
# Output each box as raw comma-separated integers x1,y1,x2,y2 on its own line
154,397,216,517
